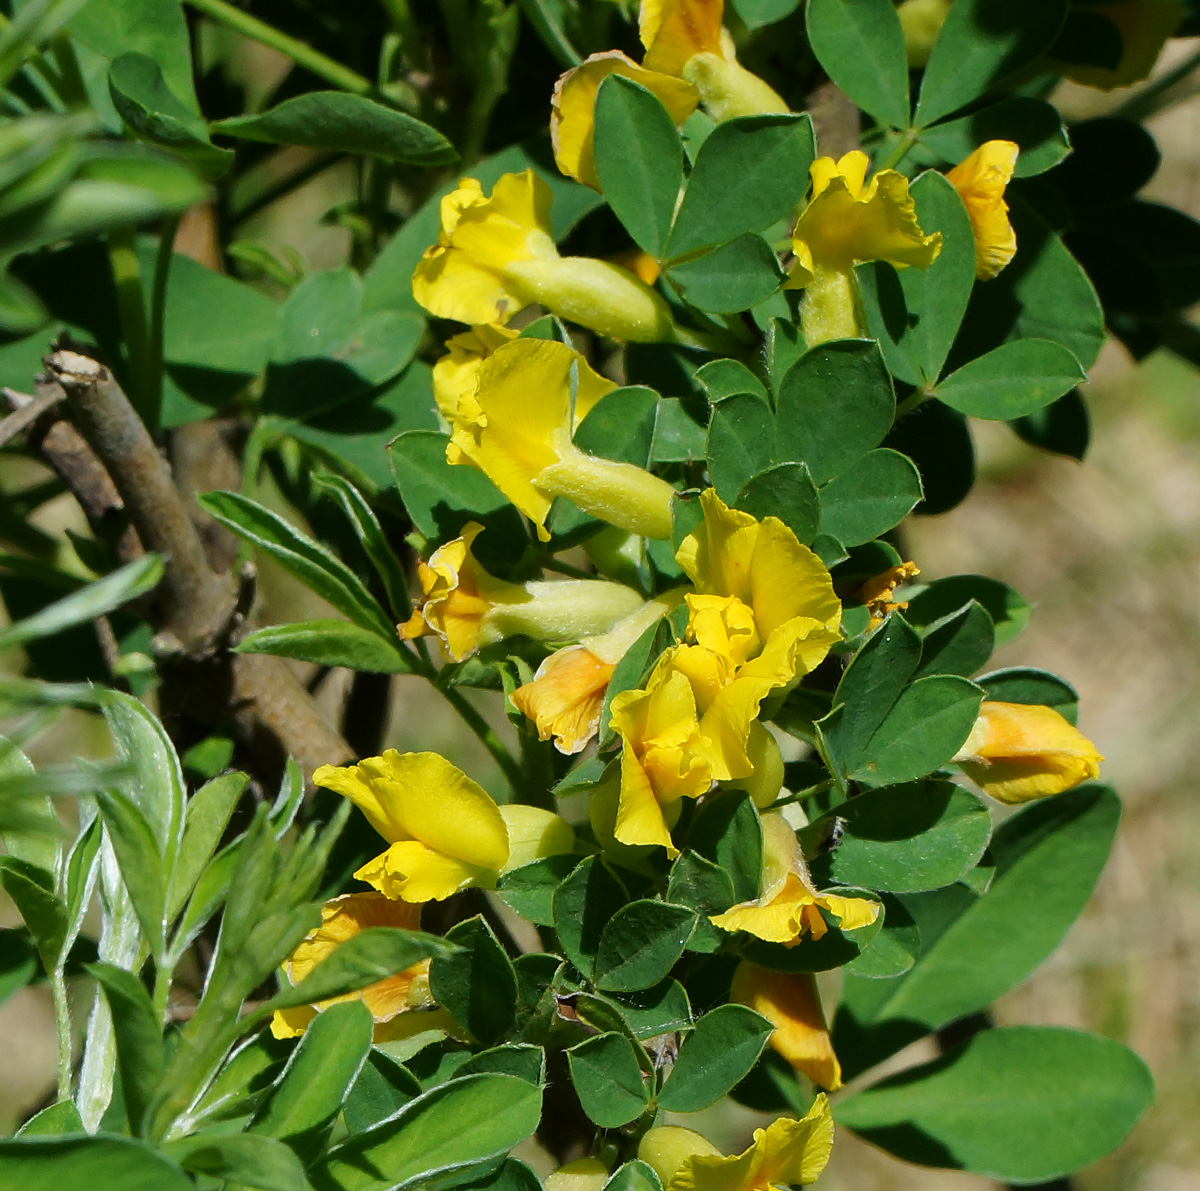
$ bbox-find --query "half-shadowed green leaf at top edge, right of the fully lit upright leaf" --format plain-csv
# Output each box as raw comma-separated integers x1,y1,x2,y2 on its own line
913,0,1067,128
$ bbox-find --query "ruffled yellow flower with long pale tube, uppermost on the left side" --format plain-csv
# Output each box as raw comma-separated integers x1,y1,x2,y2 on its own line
413,169,676,343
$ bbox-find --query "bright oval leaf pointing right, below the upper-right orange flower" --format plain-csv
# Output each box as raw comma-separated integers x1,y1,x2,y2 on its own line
935,339,1087,421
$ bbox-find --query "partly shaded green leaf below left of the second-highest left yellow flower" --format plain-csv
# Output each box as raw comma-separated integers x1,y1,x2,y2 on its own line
388,427,530,557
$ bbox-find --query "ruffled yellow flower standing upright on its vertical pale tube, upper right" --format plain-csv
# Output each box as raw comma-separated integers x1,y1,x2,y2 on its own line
787,149,942,347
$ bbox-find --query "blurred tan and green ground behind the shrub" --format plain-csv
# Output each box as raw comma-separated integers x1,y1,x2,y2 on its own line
0,38,1200,1191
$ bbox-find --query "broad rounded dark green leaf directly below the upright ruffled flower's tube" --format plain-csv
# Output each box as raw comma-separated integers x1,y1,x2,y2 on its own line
774,336,897,485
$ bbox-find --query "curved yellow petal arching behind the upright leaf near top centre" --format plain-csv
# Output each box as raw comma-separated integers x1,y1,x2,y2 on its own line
550,49,700,189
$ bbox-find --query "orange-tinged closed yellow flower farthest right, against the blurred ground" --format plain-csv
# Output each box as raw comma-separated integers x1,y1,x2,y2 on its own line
953,702,1104,804
